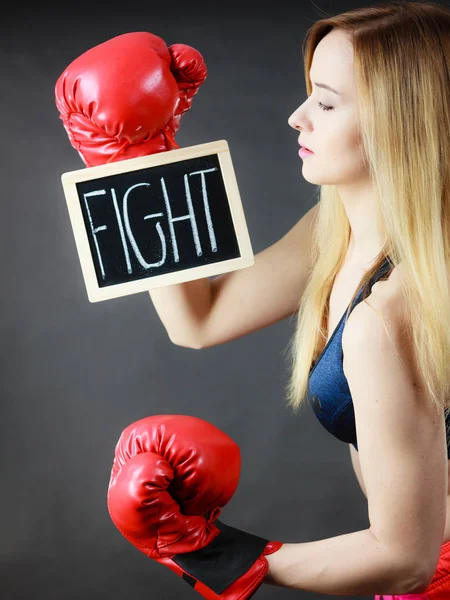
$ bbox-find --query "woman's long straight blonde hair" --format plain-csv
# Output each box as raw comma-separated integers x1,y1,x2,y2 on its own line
285,1,450,428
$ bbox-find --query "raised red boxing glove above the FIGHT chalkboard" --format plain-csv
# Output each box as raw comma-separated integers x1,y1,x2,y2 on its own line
55,32,206,167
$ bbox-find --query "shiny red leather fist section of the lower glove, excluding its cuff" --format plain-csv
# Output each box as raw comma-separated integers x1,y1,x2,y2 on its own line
108,415,241,558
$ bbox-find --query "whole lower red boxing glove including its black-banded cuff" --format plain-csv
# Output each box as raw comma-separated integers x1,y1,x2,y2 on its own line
108,415,282,600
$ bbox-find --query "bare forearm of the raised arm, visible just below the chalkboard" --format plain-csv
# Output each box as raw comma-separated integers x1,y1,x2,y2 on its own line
149,277,211,347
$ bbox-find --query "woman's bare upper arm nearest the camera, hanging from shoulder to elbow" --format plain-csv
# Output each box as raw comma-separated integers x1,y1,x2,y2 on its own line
342,280,447,581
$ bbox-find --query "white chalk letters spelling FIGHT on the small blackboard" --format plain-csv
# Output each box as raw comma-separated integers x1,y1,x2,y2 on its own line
83,167,218,279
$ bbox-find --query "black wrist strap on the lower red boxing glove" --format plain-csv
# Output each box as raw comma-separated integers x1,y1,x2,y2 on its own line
172,519,269,594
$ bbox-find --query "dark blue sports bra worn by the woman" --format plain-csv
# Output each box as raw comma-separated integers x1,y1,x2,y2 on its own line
307,257,450,459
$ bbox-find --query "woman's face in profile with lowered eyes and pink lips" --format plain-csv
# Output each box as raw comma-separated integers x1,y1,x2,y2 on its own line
288,29,368,185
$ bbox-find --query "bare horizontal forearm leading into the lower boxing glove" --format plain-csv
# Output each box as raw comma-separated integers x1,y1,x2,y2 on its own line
264,529,421,596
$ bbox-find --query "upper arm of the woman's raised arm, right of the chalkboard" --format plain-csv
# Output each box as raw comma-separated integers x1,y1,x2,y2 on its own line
199,204,318,348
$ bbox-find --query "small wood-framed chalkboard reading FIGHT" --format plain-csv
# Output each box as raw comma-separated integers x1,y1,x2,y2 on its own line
61,140,254,302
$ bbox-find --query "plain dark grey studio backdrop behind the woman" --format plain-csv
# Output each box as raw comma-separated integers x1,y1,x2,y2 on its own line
0,0,440,600
